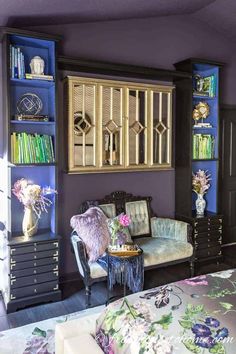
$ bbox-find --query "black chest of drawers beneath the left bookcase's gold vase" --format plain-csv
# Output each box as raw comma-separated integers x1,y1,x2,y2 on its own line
6,234,61,312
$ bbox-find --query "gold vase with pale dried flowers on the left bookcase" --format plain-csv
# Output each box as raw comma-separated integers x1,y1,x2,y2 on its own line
12,178,57,237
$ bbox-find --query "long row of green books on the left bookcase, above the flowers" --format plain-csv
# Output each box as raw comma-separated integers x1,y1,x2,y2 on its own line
11,132,55,164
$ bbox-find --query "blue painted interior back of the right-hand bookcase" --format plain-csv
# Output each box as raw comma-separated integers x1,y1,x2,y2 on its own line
192,63,219,213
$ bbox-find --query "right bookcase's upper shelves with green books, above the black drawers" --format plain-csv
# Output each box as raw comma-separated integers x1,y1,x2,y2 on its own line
175,59,223,217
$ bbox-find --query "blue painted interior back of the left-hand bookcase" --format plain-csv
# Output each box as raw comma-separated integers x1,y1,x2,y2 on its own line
9,35,57,236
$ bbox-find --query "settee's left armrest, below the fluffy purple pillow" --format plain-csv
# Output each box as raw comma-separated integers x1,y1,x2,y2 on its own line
71,231,90,280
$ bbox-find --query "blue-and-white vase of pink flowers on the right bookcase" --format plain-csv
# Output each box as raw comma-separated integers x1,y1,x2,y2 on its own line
192,170,211,216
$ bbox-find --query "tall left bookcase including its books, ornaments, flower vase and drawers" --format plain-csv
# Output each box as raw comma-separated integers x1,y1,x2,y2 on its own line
0,29,61,312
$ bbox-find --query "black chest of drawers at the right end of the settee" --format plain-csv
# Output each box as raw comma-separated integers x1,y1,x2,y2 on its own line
177,213,223,262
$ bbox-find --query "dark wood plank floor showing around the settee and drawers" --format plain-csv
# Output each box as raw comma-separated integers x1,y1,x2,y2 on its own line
0,262,232,331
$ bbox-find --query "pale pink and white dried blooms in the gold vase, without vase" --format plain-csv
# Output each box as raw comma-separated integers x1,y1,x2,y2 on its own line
12,178,57,218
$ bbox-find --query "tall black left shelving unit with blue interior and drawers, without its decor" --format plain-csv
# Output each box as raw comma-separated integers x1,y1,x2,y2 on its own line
1,28,61,312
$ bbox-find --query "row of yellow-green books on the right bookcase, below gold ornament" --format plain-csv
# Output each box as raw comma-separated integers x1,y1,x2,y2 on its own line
193,134,215,159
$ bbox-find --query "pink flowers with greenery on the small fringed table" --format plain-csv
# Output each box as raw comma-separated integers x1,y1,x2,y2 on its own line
108,213,131,246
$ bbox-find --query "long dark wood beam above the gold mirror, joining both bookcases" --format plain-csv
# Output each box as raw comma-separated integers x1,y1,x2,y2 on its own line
58,56,191,81
